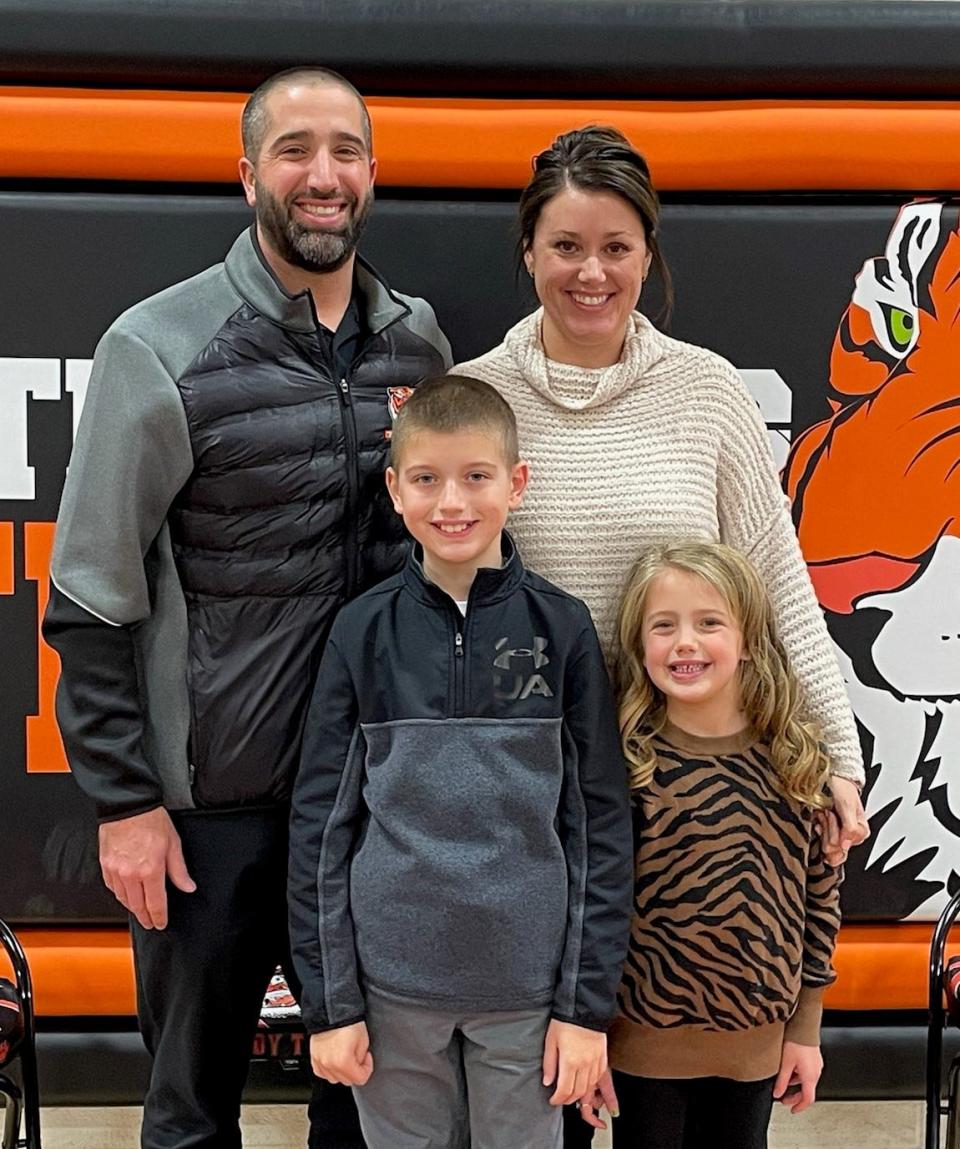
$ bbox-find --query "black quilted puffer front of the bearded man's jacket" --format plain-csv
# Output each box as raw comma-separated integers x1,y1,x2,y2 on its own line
169,271,446,807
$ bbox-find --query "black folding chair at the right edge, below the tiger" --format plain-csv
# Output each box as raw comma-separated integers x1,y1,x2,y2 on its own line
924,890,960,1149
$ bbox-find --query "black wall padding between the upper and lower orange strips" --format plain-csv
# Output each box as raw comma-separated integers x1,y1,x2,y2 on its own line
0,191,934,923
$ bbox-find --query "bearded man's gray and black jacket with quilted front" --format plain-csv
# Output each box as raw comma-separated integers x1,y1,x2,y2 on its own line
44,229,449,818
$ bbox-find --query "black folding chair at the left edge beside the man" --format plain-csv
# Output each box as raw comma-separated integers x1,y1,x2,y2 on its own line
0,919,40,1149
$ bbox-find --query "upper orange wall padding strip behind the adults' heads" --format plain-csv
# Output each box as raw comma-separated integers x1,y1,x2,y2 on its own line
0,87,960,193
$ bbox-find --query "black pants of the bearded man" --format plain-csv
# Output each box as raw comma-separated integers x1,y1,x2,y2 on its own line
132,810,363,1149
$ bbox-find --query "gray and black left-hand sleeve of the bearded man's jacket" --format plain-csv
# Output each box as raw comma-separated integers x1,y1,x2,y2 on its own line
44,321,193,819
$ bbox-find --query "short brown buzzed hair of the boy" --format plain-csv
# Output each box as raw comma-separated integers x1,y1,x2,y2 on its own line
390,375,520,470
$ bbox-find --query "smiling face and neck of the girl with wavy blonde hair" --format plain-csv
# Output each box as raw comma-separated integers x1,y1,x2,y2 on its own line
642,568,746,735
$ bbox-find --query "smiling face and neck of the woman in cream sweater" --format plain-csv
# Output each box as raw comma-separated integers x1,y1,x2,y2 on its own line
524,186,651,367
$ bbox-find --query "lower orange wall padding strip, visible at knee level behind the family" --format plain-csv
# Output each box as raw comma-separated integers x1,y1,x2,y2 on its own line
0,921,960,1017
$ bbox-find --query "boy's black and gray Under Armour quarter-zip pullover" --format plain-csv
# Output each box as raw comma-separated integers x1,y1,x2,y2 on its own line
289,542,633,1031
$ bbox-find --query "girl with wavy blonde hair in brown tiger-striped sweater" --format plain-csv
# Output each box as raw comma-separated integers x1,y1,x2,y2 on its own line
581,542,841,1149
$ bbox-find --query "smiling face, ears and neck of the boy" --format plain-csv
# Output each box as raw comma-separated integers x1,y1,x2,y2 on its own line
387,427,528,597
